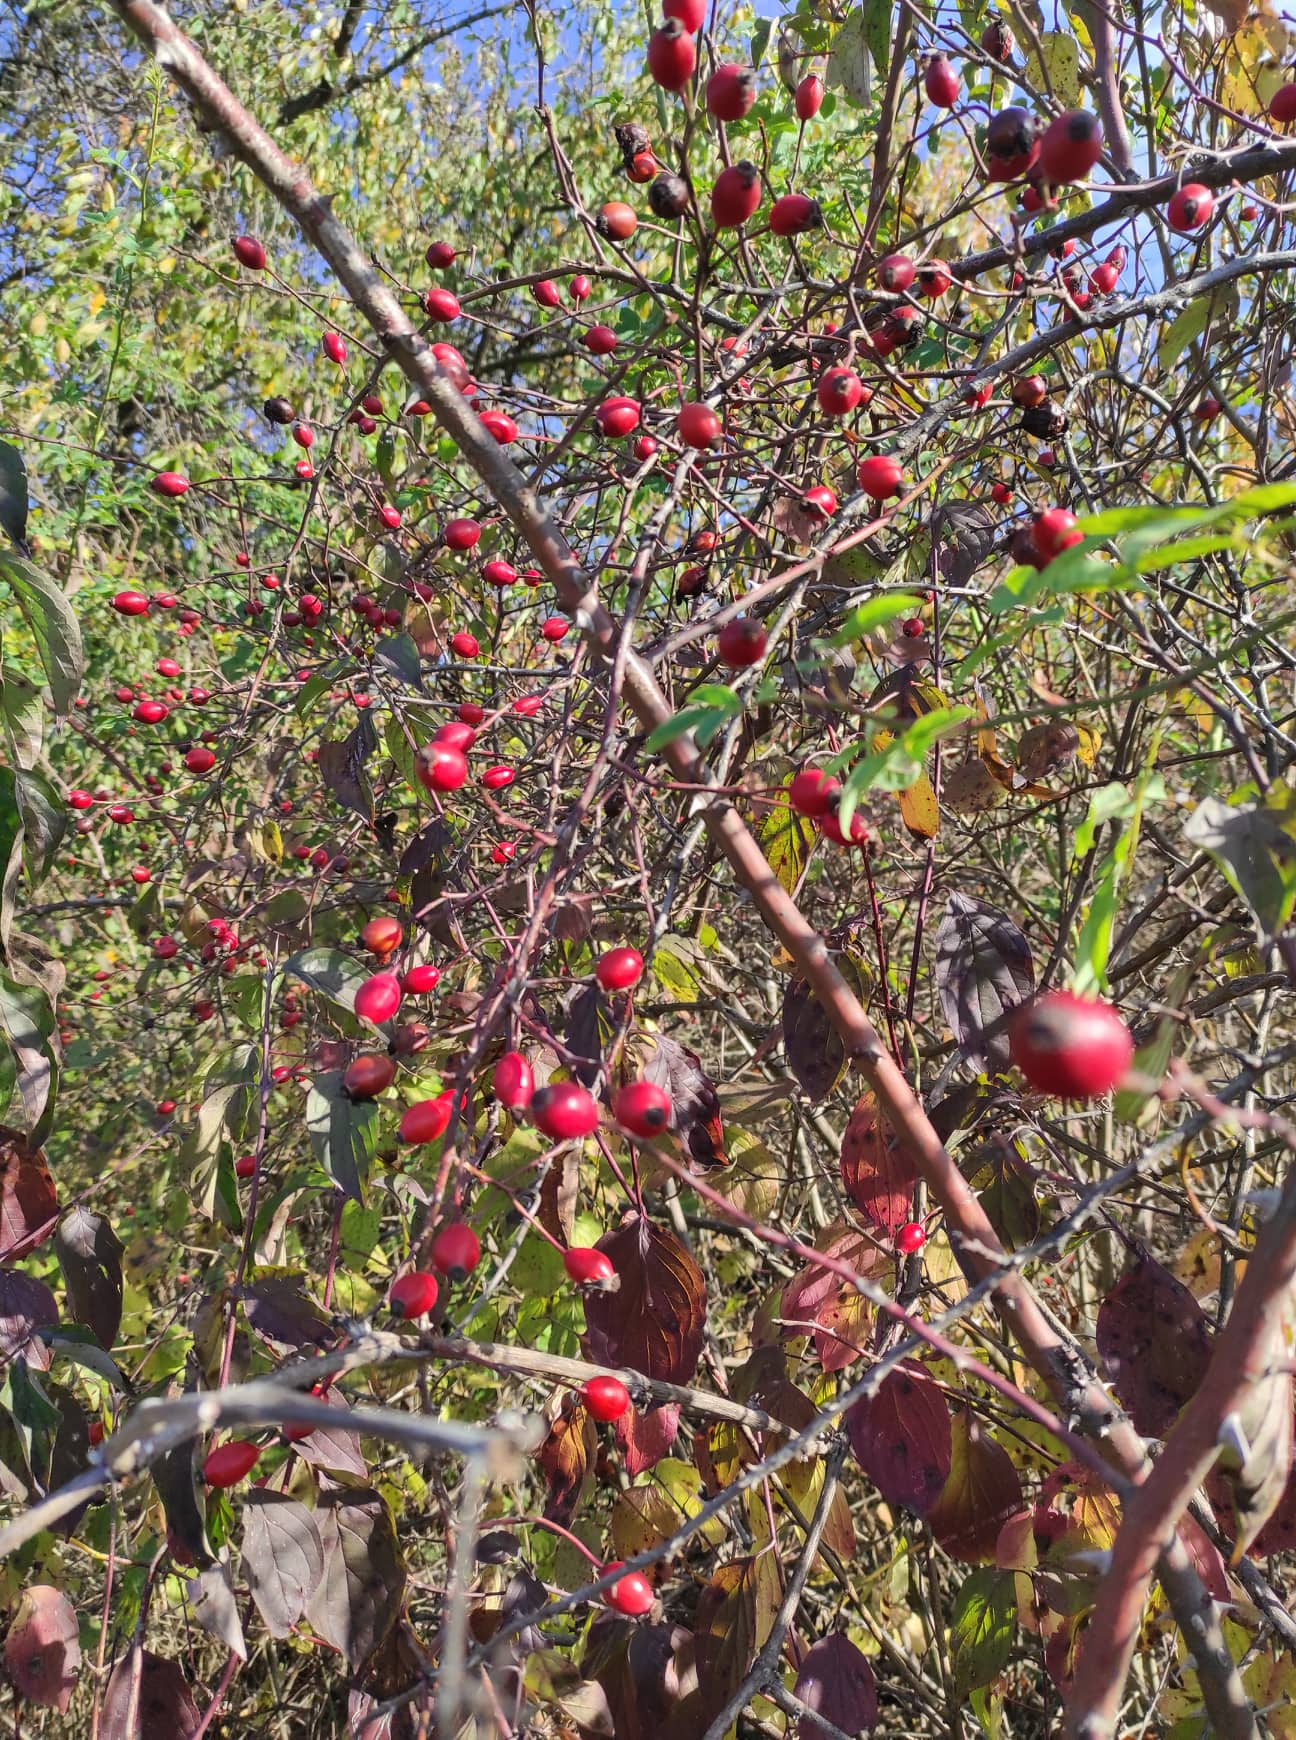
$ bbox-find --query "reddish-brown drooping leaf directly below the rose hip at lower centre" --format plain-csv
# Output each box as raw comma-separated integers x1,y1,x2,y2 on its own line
585,1215,706,1383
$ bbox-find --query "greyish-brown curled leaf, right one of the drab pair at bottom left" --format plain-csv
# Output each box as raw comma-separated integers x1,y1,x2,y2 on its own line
306,1489,405,1672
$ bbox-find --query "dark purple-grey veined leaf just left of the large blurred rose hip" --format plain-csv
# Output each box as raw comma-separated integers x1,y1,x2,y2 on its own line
936,893,1035,1070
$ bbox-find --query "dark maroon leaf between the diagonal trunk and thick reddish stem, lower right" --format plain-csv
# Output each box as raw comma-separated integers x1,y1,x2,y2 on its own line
1096,1253,1211,1437
